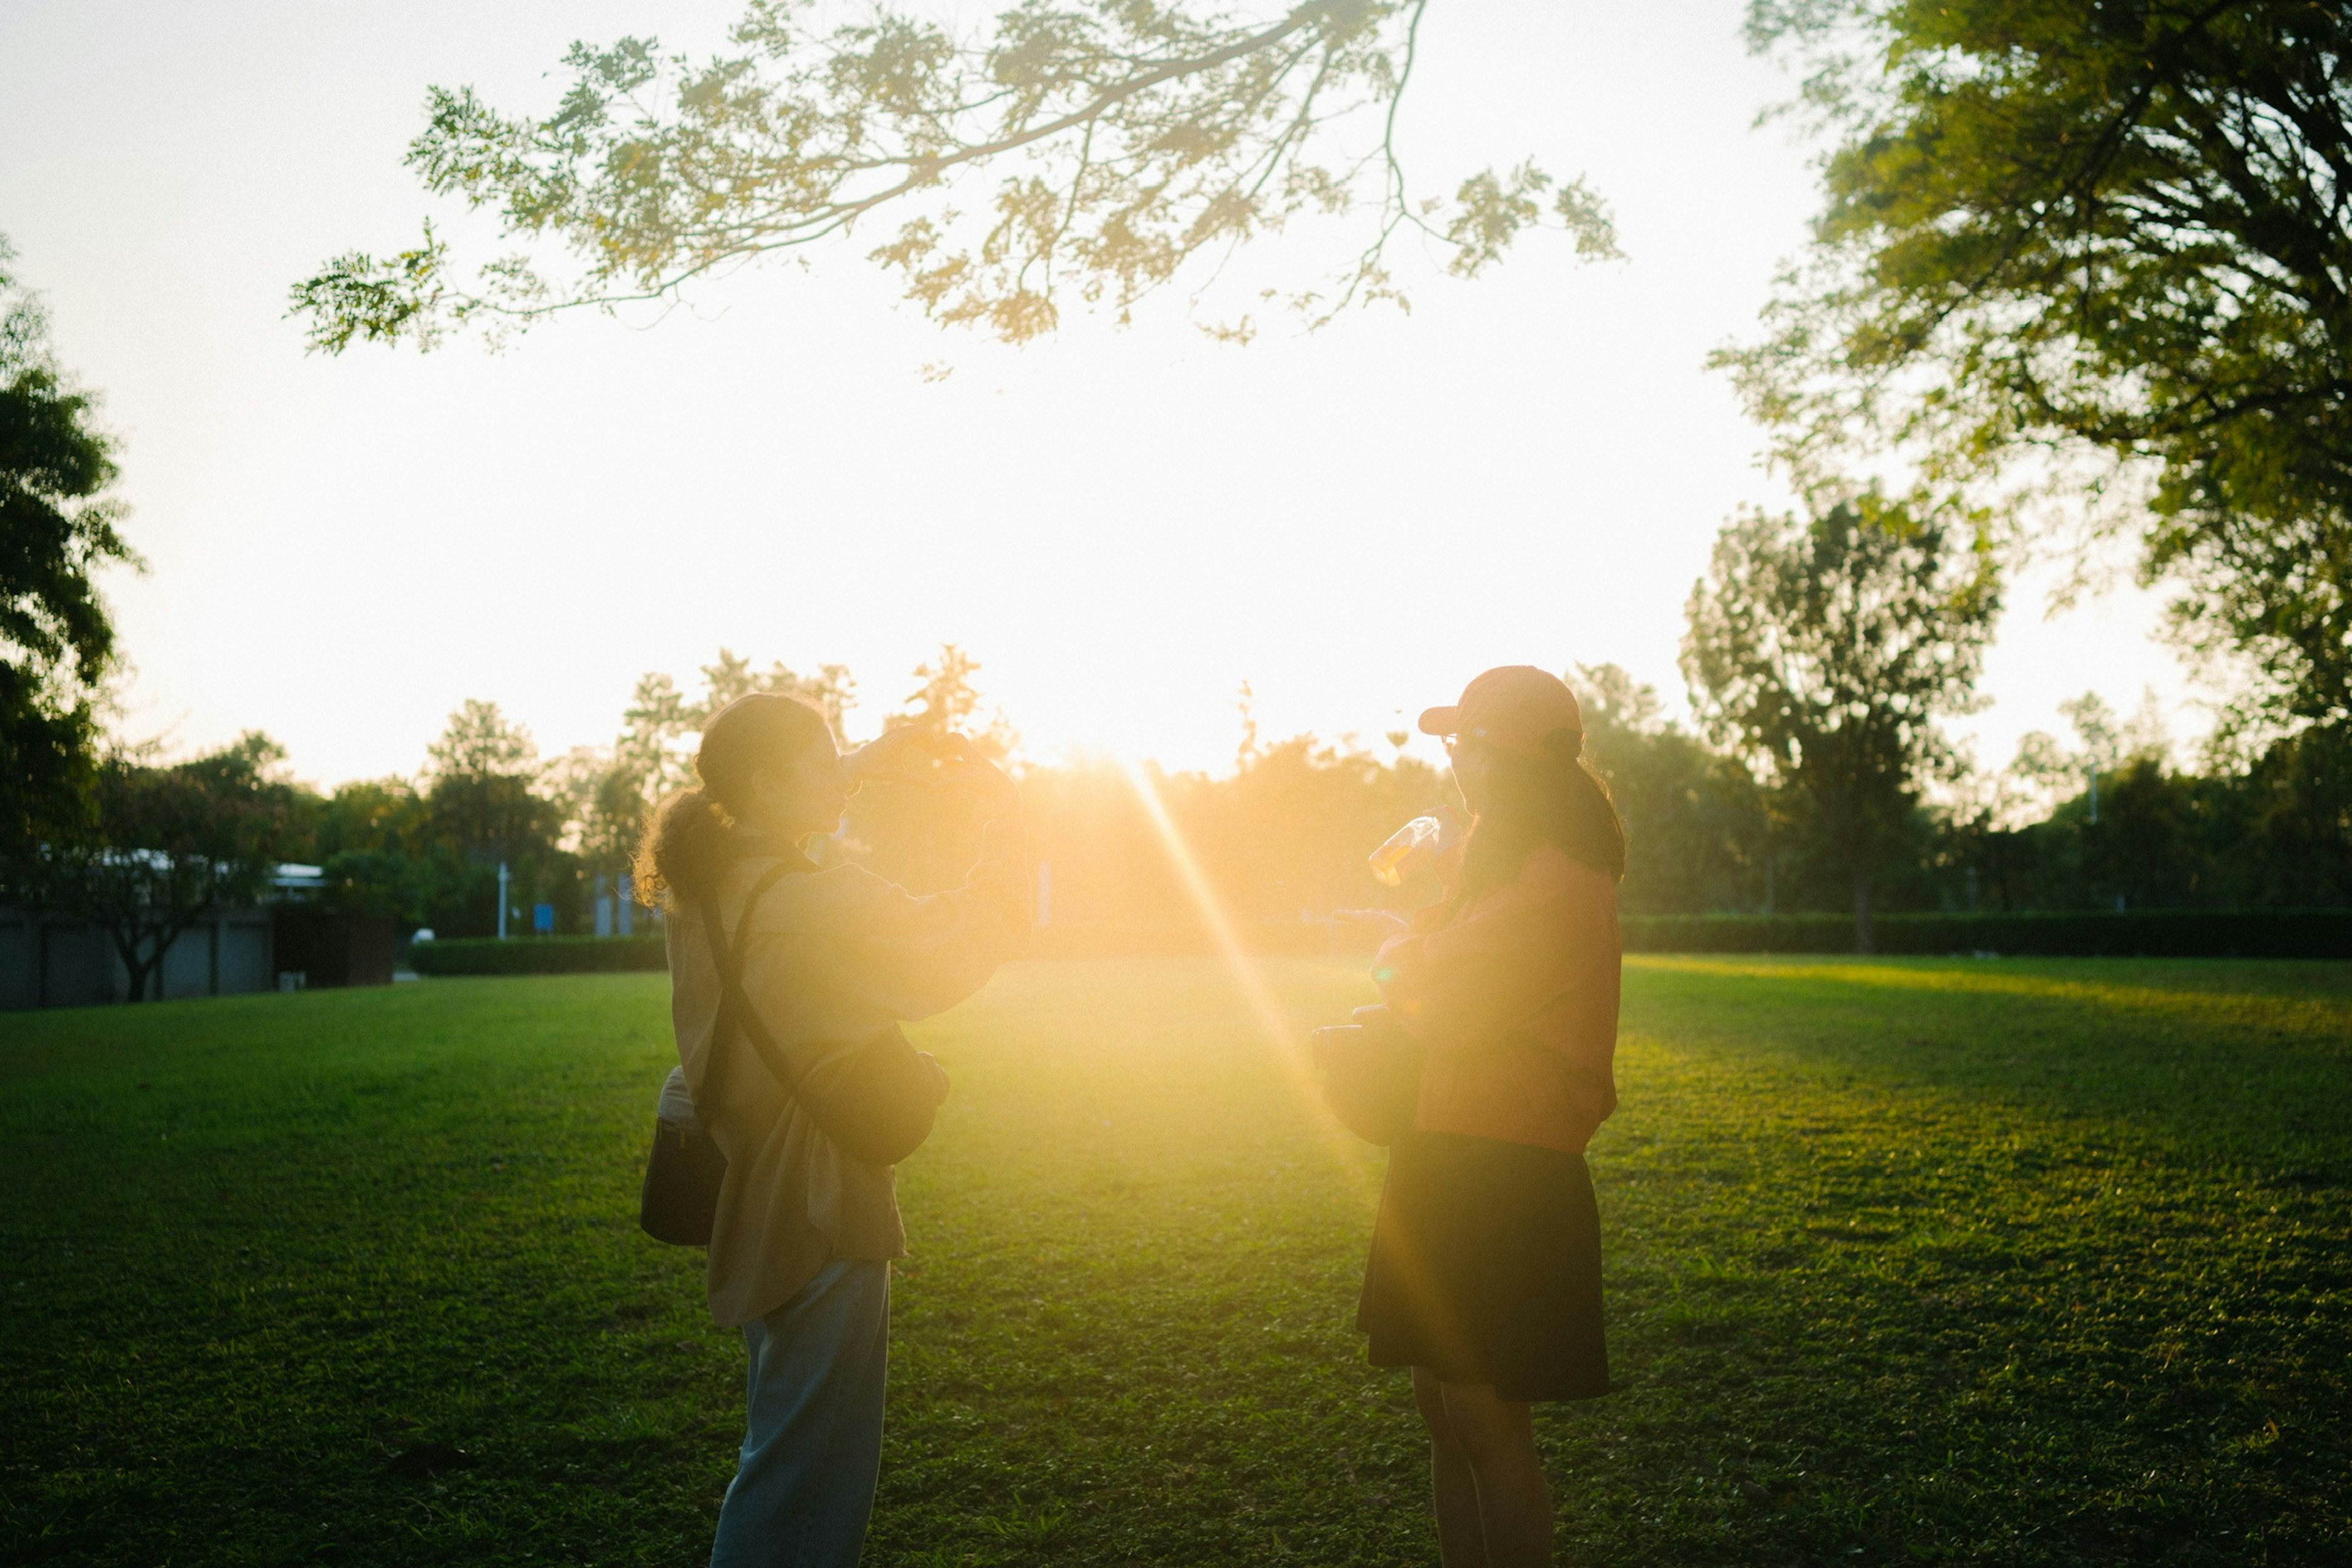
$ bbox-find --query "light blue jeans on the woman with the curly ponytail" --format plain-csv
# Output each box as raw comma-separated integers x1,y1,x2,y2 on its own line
710,1257,889,1568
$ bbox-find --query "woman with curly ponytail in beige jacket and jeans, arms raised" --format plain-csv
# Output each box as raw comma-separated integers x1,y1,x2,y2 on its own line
638,693,1030,1568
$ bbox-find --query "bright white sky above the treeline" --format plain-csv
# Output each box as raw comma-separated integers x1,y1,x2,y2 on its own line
0,0,2201,783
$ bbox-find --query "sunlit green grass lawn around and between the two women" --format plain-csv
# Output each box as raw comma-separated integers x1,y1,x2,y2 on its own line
0,957,2352,1568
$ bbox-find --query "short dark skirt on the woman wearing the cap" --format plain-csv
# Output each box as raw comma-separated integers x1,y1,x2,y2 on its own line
1355,1133,1609,1401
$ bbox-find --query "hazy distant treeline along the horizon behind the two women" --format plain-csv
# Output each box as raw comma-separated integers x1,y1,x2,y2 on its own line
202,649,2352,948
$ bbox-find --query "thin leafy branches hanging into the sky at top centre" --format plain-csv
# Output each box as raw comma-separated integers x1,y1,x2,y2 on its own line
294,0,1616,353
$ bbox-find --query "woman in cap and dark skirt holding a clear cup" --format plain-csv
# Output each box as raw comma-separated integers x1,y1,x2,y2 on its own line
1357,665,1625,1568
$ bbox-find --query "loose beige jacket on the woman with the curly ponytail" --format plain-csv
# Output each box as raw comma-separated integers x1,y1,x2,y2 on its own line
668,818,1030,1329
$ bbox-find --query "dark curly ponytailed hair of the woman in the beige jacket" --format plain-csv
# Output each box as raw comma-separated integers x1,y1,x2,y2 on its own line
633,691,832,910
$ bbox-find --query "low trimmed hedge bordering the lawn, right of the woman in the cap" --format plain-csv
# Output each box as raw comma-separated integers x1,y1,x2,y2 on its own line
1621,910,2352,959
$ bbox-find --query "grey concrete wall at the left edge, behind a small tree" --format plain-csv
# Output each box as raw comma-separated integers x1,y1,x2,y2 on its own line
0,910,277,1009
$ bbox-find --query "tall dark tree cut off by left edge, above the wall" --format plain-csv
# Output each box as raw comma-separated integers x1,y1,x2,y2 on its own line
0,238,139,872
